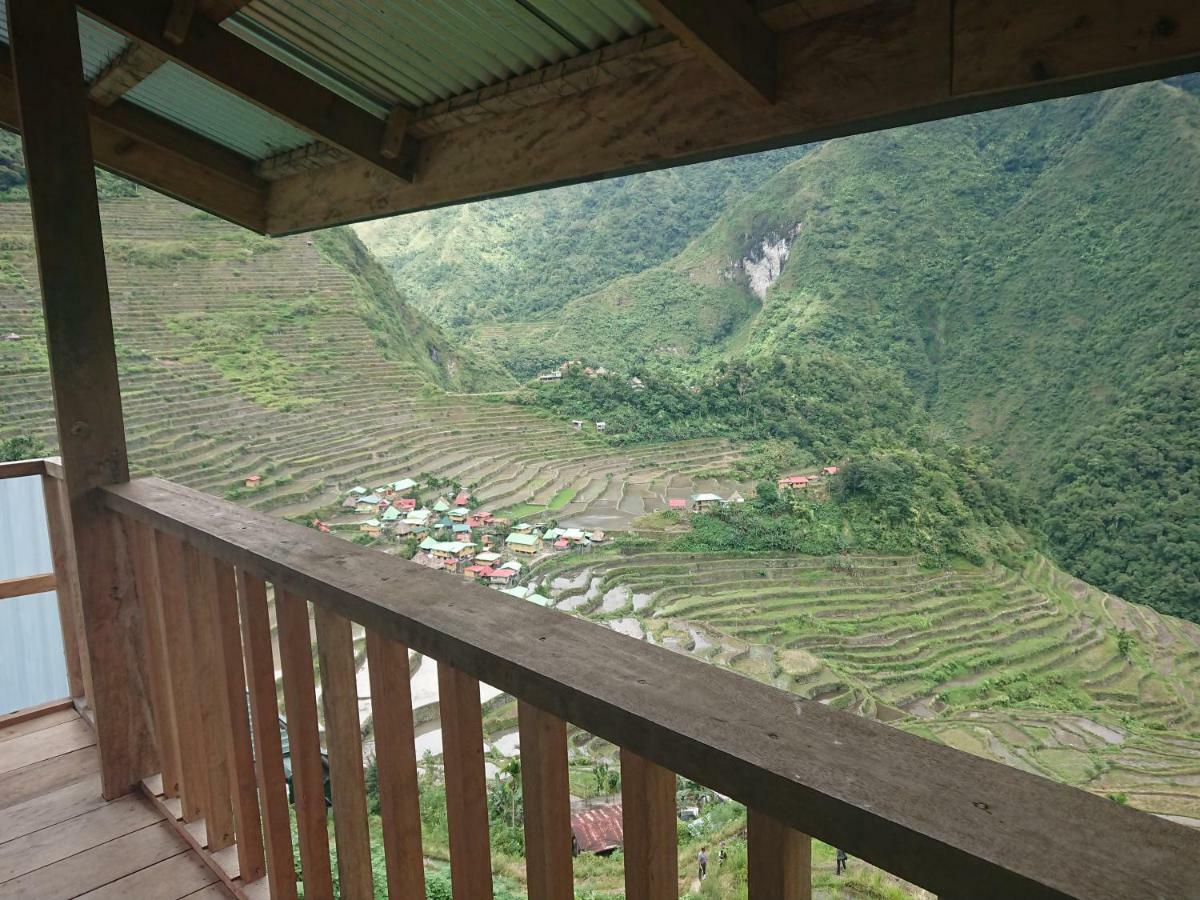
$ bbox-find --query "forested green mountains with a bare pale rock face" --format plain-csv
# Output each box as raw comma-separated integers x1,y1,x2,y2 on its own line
364,77,1200,617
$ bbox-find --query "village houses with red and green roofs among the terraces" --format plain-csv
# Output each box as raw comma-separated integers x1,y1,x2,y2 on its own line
245,466,840,606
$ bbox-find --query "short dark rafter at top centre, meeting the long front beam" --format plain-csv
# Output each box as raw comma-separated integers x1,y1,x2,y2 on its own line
640,0,778,103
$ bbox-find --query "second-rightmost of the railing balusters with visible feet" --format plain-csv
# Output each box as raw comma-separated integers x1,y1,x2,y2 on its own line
184,544,234,851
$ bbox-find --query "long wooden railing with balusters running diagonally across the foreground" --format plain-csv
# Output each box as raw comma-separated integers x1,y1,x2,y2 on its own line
11,479,1200,900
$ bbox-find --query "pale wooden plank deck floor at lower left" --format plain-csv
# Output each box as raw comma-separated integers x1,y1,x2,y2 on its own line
0,709,230,900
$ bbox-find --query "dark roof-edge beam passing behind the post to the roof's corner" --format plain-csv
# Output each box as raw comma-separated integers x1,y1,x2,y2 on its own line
0,47,266,232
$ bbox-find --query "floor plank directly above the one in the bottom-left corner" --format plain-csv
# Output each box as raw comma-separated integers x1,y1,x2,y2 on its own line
0,794,160,884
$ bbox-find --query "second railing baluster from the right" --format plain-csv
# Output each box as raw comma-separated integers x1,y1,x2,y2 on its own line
620,749,679,900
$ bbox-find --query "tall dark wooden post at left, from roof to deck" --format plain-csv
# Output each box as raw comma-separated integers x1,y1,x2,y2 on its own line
7,0,158,798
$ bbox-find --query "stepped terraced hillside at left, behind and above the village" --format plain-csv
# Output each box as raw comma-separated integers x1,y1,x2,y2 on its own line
0,196,738,528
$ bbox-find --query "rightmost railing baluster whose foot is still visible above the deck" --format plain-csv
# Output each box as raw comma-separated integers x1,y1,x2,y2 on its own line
209,560,266,882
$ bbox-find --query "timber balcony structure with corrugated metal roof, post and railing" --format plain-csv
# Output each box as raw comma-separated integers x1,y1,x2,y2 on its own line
0,0,1200,900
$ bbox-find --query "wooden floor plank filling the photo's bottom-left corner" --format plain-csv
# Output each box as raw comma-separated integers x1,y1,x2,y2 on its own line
0,816,186,900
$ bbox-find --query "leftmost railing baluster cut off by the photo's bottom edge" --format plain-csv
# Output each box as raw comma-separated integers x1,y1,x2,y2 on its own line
236,569,296,900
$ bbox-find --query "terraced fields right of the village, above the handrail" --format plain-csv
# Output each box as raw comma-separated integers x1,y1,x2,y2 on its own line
541,552,1200,827
